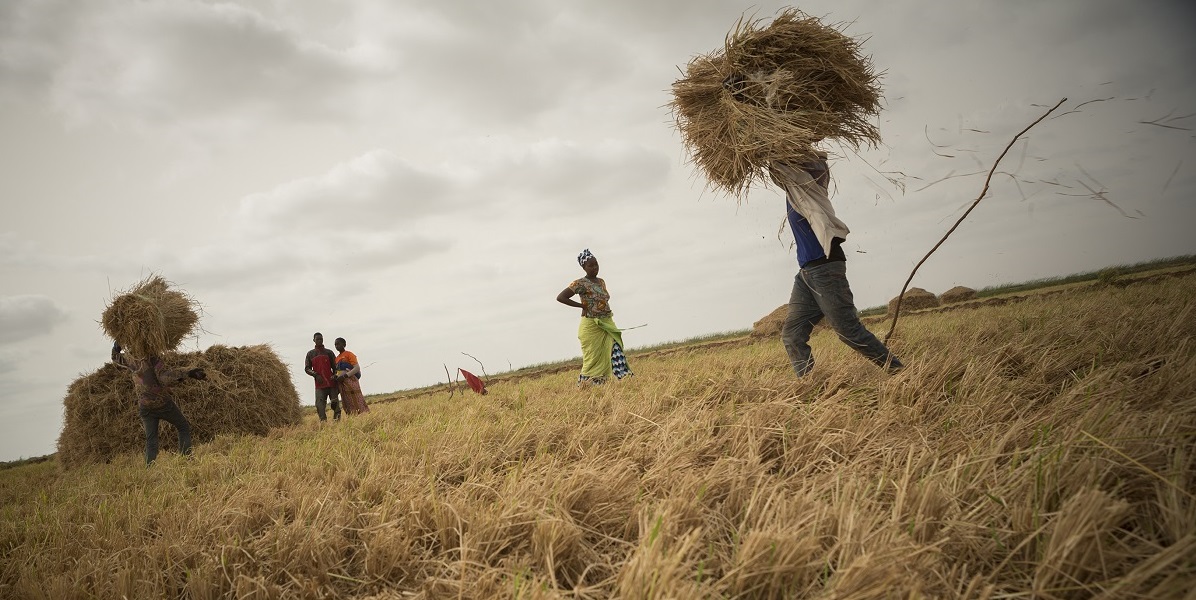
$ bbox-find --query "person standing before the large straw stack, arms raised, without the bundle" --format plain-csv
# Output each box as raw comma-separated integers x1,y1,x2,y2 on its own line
112,343,207,465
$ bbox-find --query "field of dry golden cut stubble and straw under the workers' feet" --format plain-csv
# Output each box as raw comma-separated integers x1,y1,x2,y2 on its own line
0,276,1196,599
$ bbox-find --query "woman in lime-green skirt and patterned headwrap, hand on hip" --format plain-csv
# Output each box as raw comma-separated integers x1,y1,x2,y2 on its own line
556,249,633,386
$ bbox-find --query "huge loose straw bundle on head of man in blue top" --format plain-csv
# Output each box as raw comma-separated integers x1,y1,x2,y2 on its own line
671,8,881,200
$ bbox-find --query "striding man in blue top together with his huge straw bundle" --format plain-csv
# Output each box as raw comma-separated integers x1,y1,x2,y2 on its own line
672,10,902,376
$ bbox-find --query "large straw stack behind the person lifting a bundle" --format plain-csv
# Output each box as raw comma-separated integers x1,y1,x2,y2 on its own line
57,345,303,467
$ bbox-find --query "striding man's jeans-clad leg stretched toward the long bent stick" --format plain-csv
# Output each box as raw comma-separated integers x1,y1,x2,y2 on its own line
803,261,902,372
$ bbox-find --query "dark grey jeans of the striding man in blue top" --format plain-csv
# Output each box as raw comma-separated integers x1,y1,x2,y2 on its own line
781,261,902,376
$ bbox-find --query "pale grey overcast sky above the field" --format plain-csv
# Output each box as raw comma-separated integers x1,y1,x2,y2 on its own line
0,0,1196,460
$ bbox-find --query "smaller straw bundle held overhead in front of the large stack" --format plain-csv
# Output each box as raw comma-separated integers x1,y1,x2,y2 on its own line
100,275,200,357
